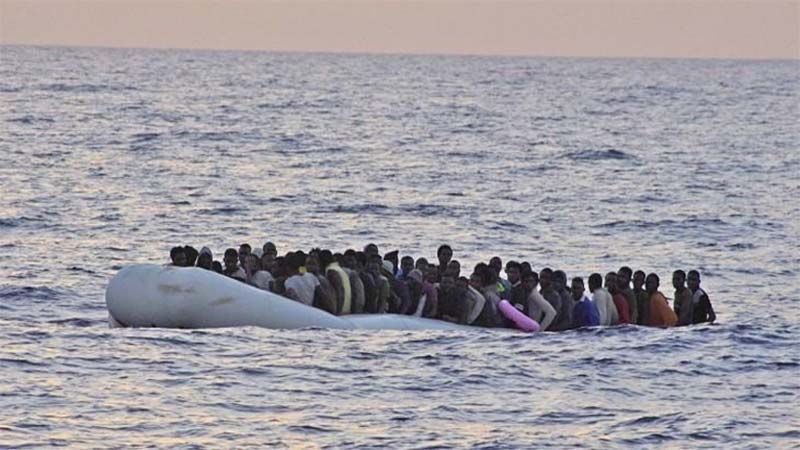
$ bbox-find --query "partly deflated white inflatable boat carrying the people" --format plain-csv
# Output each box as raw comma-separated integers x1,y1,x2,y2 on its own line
106,264,475,330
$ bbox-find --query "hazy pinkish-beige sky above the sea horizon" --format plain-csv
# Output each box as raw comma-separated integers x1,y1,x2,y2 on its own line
0,0,800,58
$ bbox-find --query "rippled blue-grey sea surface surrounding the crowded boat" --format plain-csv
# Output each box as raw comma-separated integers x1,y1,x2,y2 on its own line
0,47,800,449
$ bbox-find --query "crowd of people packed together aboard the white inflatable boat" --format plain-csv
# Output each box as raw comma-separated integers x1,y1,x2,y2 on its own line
170,242,716,331
